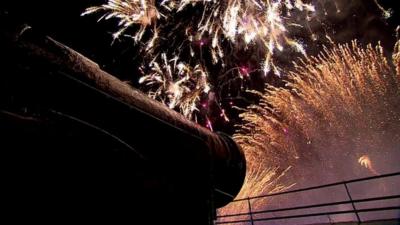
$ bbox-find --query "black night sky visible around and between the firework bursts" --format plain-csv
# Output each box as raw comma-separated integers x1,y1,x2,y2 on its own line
2,0,400,134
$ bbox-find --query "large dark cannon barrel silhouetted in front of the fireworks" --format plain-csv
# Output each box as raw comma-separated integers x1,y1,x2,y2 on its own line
0,15,246,225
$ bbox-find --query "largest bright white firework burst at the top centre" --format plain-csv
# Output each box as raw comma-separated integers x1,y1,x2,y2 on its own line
186,0,315,74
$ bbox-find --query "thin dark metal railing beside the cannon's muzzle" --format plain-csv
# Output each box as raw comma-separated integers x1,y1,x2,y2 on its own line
215,172,400,225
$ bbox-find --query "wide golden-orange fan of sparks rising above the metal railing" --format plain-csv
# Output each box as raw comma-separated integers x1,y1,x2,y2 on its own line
221,39,400,214
